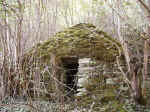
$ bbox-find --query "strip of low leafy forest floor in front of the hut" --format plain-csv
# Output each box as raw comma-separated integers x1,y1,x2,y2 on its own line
0,98,150,112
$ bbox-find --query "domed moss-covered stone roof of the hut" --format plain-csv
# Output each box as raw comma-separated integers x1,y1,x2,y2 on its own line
28,23,121,62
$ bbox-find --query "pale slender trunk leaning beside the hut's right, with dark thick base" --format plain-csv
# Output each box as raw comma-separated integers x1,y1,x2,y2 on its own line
117,1,145,104
